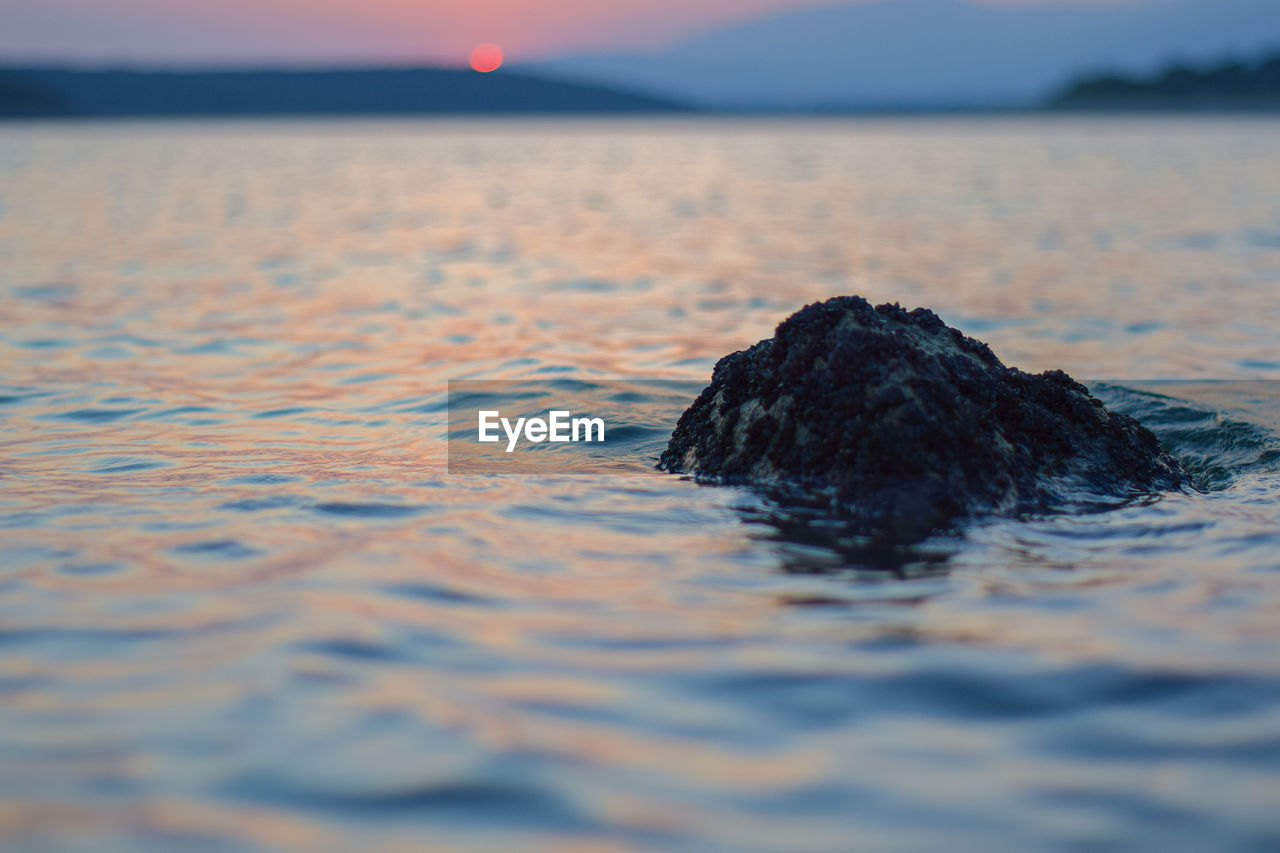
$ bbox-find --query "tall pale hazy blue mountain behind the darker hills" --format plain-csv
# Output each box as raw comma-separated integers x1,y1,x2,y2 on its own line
527,0,1280,109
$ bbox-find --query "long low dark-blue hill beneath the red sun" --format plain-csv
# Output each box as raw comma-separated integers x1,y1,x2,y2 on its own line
0,68,689,118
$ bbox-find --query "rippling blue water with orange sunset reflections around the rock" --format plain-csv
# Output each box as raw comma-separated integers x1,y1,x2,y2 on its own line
0,119,1280,852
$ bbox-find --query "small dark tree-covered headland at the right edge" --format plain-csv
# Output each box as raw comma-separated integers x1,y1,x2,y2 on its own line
1050,54,1280,110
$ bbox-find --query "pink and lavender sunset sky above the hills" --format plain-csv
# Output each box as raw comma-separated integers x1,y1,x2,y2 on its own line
0,0,1133,65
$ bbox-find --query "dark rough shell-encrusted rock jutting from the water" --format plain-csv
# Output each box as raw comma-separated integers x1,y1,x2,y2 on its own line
658,296,1189,537
